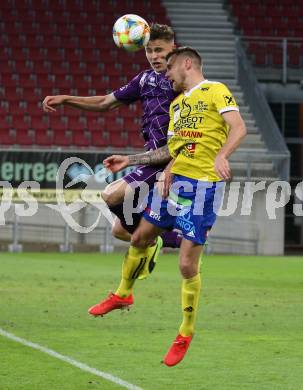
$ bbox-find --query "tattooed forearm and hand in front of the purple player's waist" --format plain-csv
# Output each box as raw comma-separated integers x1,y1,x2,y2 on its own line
103,145,171,173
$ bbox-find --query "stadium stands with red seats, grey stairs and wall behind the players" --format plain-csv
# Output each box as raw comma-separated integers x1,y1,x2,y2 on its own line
0,0,303,255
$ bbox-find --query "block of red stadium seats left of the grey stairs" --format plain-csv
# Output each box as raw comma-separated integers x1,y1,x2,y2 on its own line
0,0,171,148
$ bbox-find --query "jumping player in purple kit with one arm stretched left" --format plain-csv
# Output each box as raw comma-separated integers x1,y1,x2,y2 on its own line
43,24,180,273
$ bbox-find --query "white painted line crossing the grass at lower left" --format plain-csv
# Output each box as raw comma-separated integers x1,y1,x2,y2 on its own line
0,328,143,390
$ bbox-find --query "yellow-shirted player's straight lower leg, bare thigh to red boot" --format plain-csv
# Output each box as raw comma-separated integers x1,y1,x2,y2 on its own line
164,239,203,366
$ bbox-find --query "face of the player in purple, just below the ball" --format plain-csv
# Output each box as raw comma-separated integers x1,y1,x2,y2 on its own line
145,39,175,72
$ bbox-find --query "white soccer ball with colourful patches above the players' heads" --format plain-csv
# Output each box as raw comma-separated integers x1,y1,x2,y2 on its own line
113,14,150,51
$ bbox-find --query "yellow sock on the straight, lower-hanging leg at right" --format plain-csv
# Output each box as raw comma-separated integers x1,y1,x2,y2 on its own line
179,274,201,336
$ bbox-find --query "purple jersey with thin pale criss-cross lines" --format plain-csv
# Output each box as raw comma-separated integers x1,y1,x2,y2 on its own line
114,69,177,150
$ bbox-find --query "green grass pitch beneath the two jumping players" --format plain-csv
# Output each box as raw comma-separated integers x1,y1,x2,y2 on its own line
0,253,303,390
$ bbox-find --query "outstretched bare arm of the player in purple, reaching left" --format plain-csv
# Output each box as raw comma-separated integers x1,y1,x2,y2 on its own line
42,93,122,112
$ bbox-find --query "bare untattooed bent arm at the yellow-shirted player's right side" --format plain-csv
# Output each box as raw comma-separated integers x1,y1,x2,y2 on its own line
215,111,247,180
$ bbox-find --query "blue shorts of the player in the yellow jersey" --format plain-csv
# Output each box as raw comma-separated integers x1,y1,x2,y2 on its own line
143,175,225,245
